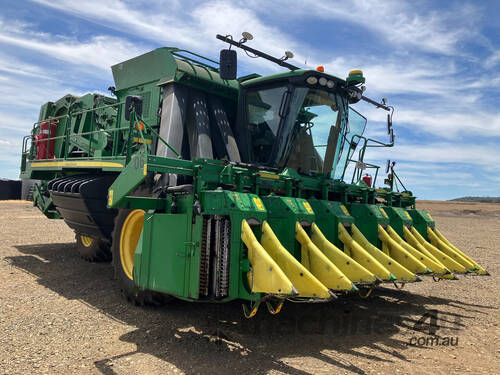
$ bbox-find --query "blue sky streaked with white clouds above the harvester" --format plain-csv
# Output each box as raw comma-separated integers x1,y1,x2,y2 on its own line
0,0,500,199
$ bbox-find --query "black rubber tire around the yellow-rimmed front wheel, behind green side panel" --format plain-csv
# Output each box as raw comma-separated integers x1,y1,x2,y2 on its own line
111,209,171,306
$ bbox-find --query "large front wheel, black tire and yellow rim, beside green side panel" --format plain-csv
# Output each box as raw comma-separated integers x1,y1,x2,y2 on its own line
112,209,169,306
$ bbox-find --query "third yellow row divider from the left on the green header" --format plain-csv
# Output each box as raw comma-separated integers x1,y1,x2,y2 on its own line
295,222,358,291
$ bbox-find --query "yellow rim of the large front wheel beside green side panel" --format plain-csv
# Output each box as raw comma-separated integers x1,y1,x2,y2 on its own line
120,210,145,280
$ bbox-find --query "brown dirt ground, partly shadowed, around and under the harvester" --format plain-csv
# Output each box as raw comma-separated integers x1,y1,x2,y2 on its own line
0,201,500,375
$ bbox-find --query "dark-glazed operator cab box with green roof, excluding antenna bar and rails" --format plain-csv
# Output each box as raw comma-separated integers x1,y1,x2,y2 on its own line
235,70,349,173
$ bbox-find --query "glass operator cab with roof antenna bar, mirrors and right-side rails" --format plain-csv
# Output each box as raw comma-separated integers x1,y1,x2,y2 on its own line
216,32,394,179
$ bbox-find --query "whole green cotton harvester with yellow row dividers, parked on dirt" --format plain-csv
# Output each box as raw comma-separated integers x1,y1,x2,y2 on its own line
21,33,488,316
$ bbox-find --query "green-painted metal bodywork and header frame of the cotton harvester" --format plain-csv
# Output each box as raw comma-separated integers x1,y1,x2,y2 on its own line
21,42,426,302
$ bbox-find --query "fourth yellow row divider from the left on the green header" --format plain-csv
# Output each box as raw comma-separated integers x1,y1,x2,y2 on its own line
311,223,379,283
